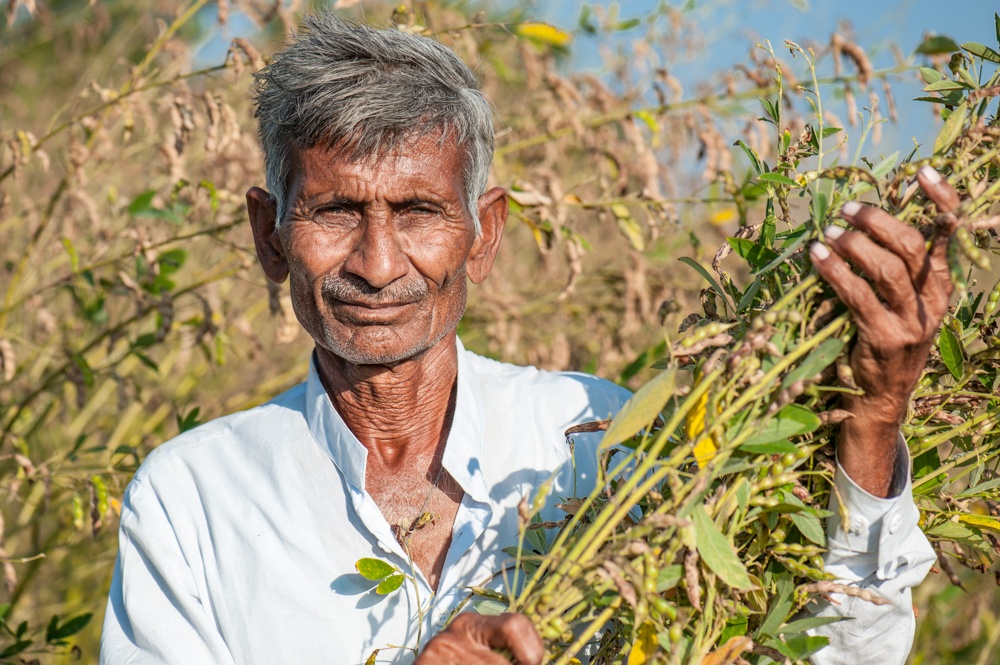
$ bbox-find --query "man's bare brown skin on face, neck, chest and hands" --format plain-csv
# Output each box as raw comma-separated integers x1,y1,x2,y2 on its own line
247,127,954,665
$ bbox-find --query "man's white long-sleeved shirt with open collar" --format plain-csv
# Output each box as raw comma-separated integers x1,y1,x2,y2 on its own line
101,344,933,665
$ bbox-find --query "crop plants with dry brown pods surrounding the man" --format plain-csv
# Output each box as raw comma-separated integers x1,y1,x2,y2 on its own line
0,0,1000,665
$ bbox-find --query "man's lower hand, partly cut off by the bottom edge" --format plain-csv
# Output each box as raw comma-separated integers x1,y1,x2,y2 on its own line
413,613,545,665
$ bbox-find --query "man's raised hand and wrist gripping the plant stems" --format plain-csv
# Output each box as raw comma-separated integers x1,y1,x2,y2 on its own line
810,166,958,497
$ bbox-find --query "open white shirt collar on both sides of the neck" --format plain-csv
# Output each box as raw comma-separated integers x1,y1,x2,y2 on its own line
305,338,489,503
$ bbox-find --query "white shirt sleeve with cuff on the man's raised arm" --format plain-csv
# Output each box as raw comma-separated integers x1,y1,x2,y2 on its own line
808,436,936,665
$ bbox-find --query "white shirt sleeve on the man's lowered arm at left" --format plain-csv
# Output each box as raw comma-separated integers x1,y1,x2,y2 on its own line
100,480,234,665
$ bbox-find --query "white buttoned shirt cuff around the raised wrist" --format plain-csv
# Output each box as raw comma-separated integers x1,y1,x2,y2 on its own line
827,435,920,580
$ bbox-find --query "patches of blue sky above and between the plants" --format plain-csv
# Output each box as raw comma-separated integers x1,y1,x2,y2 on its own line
198,0,1000,153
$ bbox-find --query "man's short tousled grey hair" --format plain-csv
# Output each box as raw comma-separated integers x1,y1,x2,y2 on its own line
253,13,493,234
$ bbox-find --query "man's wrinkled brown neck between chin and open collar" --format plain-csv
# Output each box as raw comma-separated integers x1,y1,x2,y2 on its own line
316,334,458,469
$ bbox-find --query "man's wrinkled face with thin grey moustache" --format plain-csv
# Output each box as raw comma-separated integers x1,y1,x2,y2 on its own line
262,136,506,364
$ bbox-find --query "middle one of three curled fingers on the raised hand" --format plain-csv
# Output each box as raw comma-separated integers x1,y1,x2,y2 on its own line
823,226,926,315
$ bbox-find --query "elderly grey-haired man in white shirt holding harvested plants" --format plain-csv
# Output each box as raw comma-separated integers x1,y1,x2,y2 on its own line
101,15,949,665
